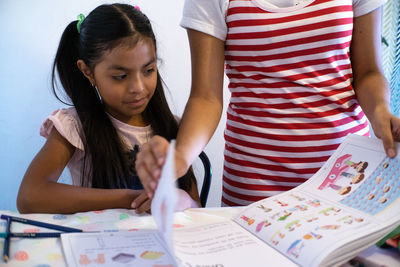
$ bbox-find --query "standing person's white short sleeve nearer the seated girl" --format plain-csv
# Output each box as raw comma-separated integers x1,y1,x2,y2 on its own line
180,0,229,41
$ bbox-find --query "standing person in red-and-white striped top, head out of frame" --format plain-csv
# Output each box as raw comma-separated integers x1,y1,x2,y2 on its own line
136,0,400,206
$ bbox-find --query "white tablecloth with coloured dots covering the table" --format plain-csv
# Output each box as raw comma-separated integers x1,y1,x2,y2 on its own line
0,208,400,267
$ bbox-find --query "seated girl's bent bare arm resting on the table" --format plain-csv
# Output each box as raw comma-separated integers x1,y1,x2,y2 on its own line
17,128,142,213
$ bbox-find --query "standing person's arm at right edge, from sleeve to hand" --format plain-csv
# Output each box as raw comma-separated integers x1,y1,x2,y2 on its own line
350,9,400,157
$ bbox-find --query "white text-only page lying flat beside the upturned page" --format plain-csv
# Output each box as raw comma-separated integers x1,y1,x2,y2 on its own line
174,220,297,267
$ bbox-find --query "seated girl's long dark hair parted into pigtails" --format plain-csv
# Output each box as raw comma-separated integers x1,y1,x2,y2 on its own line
52,4,196,191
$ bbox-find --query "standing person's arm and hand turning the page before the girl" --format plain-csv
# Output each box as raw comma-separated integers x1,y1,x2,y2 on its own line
136,30,225,197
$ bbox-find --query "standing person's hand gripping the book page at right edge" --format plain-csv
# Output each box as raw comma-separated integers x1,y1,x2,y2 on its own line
370,106,400,158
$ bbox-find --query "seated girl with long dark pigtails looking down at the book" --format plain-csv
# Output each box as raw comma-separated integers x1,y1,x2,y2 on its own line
17,4,199,213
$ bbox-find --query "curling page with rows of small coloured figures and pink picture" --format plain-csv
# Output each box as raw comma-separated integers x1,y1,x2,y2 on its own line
234,135,400,266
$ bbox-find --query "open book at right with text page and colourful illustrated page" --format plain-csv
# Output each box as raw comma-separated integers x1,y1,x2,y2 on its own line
63,135,400,267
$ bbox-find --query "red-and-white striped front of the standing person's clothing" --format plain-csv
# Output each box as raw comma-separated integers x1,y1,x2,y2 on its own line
182,0,384,206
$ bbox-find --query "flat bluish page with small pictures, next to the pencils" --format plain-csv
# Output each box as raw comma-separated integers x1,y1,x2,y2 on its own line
61,230,176,267
